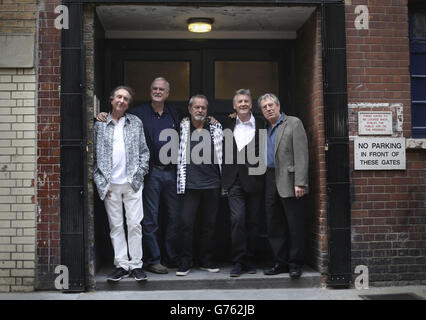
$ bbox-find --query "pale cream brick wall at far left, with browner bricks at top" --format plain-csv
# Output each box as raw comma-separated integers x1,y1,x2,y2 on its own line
0,0,37,292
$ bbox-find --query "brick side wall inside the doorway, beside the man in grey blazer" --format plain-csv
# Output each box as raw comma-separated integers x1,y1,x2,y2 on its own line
296,10,328,274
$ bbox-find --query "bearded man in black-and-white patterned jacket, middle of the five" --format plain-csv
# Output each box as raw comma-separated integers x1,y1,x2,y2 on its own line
176,94,223,276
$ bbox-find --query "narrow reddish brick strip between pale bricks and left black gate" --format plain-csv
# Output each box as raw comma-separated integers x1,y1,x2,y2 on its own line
36,0,61,289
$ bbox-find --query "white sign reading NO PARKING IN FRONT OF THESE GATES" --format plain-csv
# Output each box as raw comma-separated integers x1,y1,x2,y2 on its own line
354,138,405,170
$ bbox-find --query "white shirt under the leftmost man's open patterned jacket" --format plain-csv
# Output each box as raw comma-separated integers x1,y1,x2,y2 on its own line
111,117,127,184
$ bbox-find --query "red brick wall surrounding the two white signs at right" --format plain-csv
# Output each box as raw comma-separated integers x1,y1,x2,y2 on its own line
346,0,426,285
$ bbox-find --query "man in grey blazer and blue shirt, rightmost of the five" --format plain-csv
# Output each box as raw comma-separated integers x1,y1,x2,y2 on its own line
258,93,308,278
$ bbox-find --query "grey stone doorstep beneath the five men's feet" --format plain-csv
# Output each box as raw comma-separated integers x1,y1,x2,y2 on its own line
95,265,321,291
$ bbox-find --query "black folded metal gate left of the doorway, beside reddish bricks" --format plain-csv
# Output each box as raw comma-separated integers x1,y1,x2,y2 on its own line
60,3,87,291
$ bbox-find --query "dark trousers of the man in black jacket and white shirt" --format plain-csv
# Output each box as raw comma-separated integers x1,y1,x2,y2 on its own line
228,177,263,264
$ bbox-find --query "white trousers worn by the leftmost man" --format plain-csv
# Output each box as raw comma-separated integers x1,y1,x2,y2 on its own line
104,183,143,270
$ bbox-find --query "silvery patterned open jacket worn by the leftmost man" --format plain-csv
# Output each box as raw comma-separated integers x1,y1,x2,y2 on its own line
93,113,149,200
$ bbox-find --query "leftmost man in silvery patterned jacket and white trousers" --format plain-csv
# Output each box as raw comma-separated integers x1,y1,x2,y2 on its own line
93,86,149,281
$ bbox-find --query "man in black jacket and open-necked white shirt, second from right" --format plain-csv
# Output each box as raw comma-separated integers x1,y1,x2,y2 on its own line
222,89,265,277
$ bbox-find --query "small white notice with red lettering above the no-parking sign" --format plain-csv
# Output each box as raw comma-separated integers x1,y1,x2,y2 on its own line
358,111,393,135
